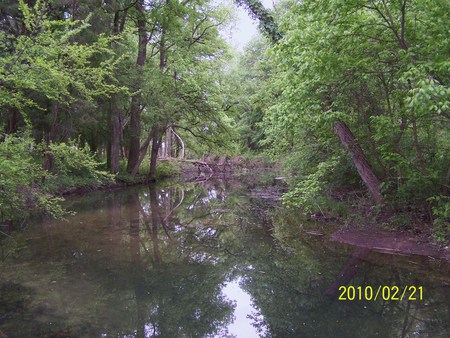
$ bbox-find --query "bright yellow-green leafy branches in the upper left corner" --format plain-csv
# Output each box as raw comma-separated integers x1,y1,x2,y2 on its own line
0,1,117,120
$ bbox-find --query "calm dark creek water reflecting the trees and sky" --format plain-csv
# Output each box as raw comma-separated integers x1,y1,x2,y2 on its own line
0,181,450,338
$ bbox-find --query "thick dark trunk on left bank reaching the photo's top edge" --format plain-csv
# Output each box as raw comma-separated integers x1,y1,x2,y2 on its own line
127,0,148,173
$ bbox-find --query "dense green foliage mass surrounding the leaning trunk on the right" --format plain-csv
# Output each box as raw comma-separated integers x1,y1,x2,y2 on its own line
253,0,450,235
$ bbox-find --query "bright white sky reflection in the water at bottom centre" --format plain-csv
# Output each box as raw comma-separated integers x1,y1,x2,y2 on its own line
222,280,268,338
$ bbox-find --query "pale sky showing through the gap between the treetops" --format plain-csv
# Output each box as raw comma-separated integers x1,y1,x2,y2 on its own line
225,0,273,51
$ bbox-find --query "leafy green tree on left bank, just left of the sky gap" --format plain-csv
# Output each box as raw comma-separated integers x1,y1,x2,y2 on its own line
123,1,236,178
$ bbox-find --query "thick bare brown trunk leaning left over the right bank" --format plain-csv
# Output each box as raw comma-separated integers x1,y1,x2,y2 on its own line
334,121,383,205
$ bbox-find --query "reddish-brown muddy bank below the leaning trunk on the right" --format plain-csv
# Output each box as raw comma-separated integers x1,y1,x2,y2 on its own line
284,187,450,263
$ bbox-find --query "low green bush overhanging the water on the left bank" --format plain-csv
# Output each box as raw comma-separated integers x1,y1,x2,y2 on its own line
0,135,113,221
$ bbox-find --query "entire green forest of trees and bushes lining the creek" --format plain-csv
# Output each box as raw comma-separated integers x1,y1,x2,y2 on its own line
0,0,450,241
